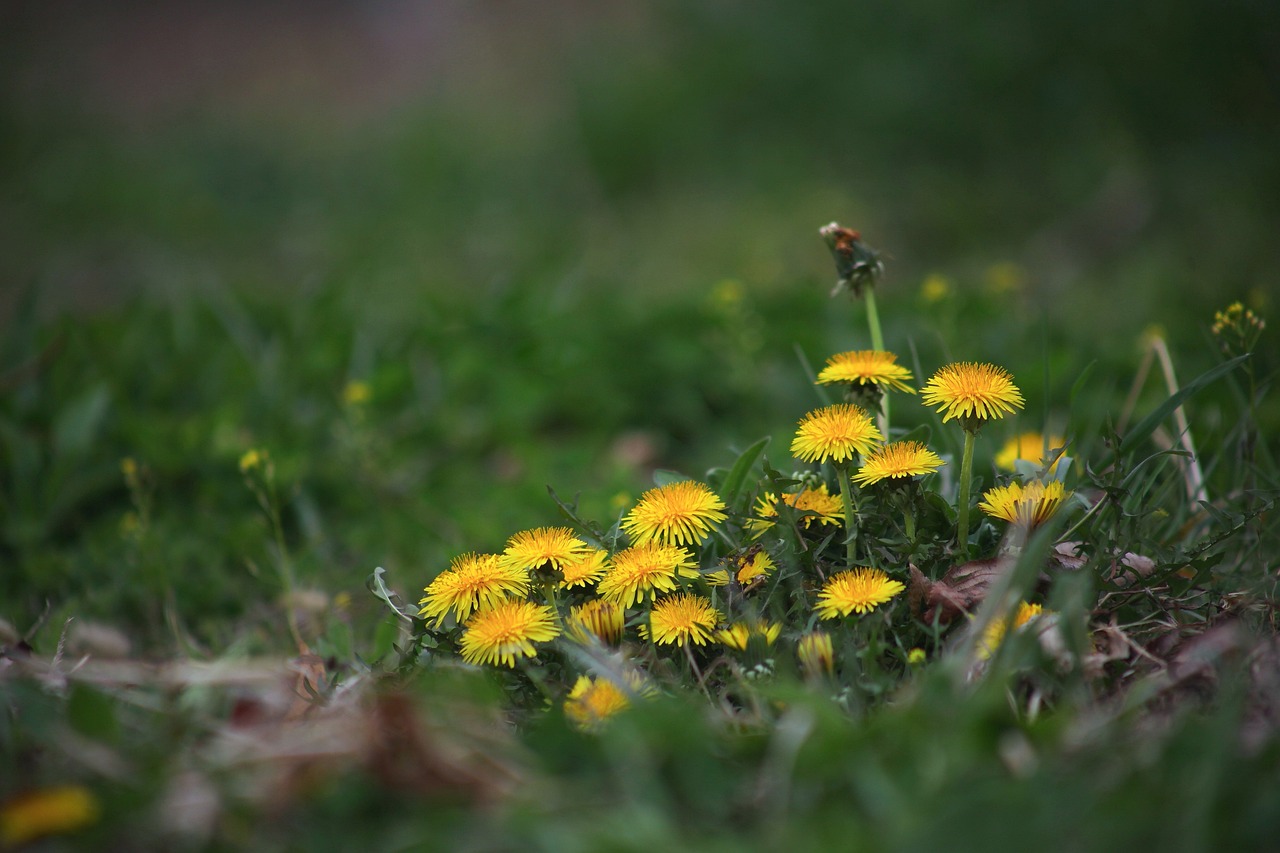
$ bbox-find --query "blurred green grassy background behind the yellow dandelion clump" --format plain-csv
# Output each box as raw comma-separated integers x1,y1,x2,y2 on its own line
0,0,1280,648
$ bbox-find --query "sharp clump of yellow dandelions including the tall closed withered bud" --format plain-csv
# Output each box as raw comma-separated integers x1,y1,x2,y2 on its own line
399,223,1262,730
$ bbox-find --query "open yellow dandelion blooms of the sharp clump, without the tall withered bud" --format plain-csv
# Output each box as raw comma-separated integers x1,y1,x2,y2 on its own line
404,338,1066,729
